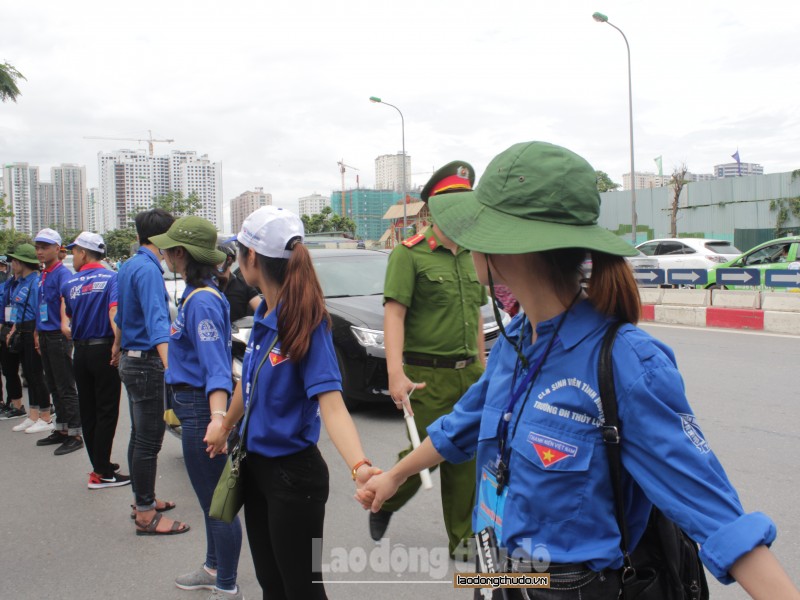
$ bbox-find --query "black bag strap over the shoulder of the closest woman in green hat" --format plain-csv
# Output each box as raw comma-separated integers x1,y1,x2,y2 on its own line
597,321,636,583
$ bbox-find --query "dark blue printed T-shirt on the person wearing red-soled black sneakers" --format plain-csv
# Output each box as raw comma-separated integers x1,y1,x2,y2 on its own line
61,263,118,340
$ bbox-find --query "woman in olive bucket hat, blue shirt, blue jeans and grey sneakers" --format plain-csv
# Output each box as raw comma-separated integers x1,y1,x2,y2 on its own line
151,216,243,600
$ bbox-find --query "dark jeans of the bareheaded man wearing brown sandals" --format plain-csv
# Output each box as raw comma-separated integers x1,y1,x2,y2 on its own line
119,351,166,511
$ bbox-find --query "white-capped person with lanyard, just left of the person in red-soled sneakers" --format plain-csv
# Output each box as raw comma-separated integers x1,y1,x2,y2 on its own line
33,229,83,456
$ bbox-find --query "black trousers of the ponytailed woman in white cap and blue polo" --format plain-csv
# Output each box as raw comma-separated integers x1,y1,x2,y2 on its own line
242,446,328,600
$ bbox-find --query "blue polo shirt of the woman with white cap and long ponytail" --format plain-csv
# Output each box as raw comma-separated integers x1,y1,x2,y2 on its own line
241,300,342,457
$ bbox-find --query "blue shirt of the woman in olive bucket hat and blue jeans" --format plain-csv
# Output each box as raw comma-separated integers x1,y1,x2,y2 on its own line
164,281,233,396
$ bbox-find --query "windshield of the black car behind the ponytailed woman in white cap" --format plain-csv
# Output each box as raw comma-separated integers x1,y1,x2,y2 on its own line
312,252,389,298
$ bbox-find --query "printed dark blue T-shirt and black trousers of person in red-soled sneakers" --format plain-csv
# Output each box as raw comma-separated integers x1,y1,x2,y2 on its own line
61,263,122,477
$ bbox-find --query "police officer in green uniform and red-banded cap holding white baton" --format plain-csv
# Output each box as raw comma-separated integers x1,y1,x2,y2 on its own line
369,161,487,555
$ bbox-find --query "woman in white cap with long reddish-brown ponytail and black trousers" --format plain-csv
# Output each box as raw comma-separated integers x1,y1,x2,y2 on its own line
206,206,376,600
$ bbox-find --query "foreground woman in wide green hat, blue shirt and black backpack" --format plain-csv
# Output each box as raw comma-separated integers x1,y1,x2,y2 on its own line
359,142,800,600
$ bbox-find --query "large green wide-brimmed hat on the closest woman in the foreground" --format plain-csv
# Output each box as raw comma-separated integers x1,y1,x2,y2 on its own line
428,142,637,256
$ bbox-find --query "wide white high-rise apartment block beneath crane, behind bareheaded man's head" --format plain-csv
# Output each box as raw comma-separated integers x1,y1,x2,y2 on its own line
97,150,222,231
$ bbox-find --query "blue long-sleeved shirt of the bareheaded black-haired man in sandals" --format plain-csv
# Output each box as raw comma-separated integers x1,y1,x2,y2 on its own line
114,248,169,350
